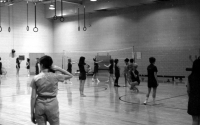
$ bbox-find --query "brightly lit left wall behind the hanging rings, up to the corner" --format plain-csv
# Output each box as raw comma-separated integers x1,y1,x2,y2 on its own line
0,1,53,76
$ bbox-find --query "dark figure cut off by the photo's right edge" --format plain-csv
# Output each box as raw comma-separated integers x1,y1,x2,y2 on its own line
187,59,200,125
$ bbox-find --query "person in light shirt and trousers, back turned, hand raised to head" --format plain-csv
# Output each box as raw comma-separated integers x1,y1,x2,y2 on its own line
31,55,73,125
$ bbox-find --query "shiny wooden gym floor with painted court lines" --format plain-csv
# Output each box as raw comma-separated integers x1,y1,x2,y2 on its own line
0,73,192,125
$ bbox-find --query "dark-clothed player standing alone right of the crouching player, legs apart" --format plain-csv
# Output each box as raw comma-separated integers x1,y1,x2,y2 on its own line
144,57,158,105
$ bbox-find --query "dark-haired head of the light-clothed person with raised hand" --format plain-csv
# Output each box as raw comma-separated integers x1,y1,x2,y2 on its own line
39,55,53,70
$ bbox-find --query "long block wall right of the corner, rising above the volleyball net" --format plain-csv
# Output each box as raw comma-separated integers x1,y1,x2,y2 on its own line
53,0,200,76
